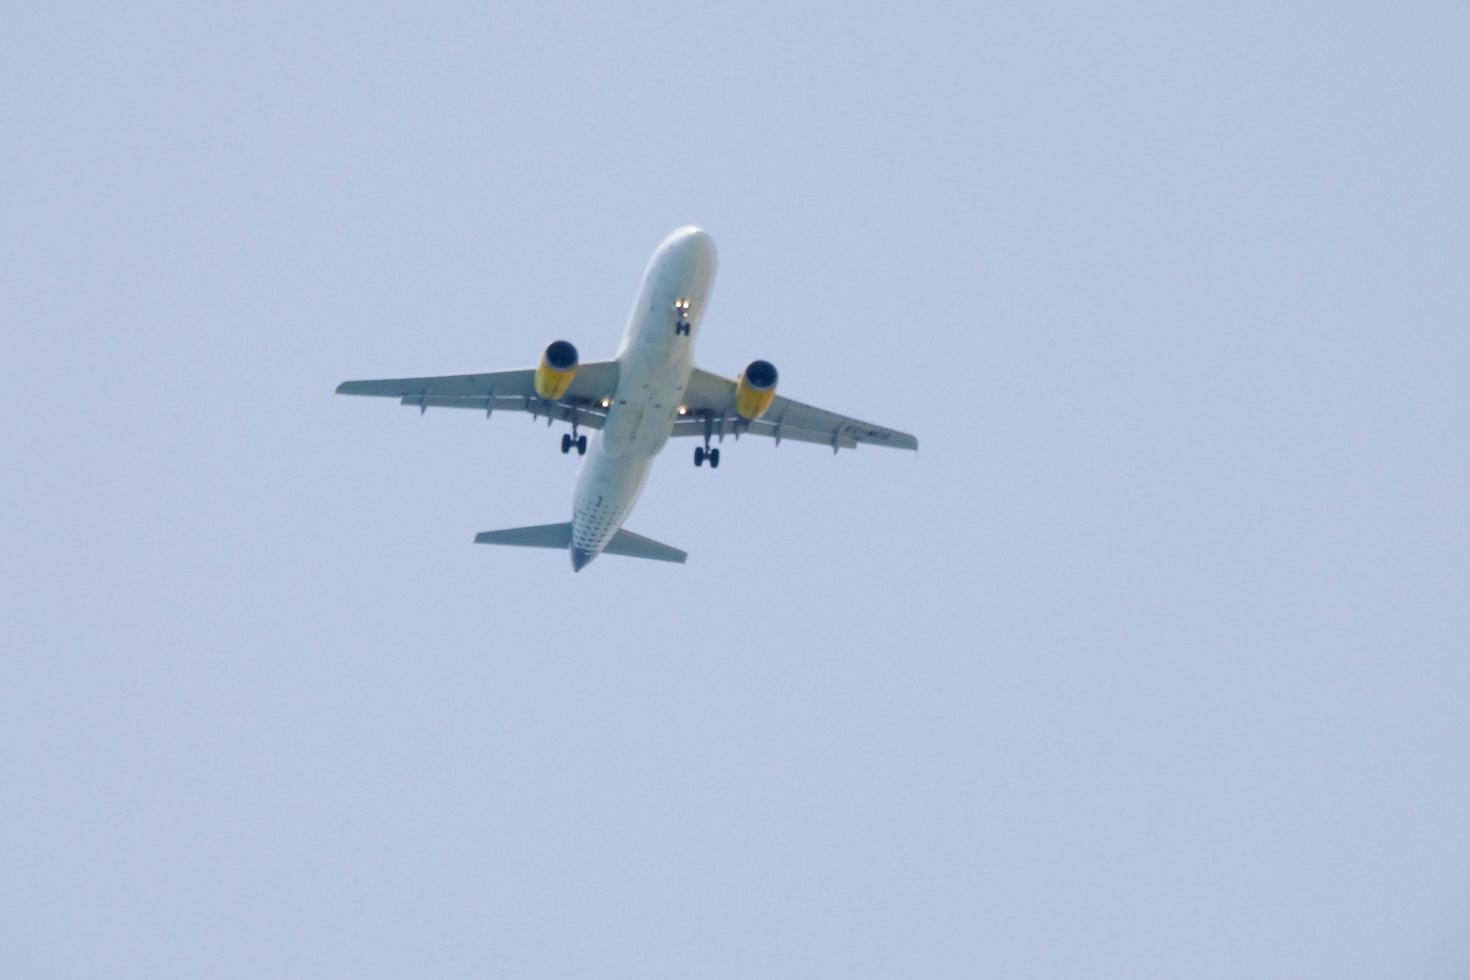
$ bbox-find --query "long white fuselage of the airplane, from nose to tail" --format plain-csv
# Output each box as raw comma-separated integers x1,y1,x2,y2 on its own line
572,228,717,570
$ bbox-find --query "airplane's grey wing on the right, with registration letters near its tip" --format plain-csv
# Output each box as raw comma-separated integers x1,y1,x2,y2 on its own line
673,367,919,453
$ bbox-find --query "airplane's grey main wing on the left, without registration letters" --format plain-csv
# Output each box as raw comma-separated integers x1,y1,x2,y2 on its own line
337,361,617,429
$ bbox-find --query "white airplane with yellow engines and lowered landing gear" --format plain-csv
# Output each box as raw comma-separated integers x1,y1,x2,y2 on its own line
337,226,919,572
